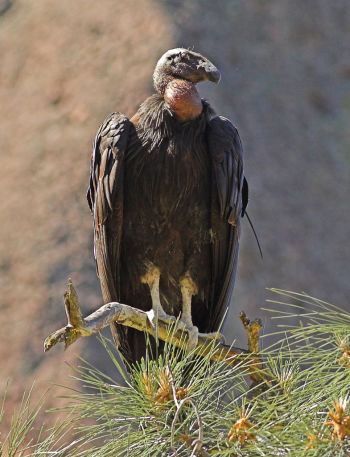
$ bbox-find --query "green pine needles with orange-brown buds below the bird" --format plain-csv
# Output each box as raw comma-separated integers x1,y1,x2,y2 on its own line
0,289,350,457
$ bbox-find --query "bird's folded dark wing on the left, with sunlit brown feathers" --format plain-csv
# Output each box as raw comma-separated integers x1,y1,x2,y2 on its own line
87,113,133,302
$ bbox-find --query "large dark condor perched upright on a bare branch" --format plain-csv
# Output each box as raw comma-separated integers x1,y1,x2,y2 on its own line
87,48,248,366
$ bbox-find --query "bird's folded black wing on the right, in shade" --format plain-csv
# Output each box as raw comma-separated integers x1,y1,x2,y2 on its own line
207,116,244,331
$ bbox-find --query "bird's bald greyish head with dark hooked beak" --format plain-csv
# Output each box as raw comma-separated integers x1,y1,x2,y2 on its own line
153,48,220,94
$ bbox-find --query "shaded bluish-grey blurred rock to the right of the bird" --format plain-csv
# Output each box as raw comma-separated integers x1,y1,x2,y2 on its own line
162,0,350,335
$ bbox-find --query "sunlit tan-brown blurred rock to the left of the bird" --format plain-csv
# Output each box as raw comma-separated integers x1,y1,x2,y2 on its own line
0,0,172,432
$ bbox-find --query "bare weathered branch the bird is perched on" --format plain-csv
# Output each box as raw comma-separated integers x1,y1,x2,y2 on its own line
44,280,270,383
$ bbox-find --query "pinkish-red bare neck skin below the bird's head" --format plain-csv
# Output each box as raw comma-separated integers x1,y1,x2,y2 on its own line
164,79,203,122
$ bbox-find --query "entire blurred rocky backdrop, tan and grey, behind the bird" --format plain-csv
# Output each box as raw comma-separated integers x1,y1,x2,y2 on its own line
0,0,350,427
